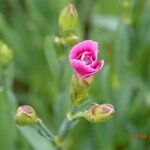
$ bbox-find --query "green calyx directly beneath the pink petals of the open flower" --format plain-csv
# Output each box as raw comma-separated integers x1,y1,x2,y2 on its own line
71,72,93,106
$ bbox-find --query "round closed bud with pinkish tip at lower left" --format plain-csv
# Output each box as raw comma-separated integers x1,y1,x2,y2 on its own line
15,105,38,126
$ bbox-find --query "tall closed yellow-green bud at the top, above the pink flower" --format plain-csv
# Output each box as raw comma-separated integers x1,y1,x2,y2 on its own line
59,4,78,36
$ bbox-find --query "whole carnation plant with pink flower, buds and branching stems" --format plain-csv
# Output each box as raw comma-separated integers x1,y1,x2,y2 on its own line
14,5,115,150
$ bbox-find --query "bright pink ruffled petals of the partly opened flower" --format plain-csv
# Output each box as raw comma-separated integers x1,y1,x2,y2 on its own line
69,40,104,78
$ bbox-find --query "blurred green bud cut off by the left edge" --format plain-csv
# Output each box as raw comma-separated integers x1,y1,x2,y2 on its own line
0,41,12,65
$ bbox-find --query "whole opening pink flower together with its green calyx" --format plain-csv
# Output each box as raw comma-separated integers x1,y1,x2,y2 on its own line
69,40,104,105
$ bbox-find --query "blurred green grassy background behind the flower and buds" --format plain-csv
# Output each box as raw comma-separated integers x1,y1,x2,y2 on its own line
0,0,150,150
